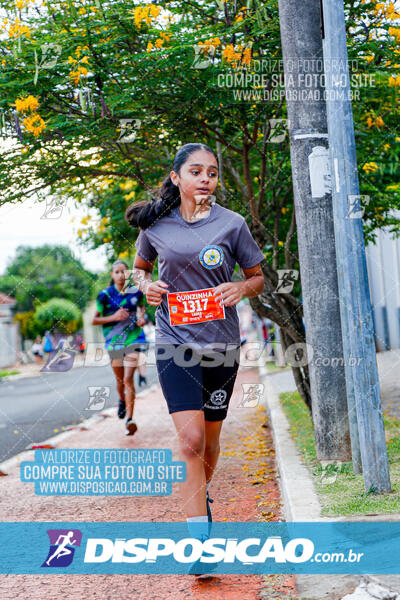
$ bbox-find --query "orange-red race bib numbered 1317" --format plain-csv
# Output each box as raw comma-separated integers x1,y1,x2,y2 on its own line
167,288,225,325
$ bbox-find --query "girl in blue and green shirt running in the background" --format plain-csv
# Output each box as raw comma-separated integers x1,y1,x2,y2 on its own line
92,260,146,435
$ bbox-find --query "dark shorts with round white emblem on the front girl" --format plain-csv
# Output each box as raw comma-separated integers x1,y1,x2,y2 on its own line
155,344,240,421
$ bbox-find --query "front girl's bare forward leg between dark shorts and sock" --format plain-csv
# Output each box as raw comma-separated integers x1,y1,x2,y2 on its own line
171,410,207,517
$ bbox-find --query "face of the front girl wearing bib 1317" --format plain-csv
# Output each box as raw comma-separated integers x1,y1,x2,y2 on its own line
171,150,218,202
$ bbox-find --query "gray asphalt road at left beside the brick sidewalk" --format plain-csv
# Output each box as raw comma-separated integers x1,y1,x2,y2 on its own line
0,365,158,463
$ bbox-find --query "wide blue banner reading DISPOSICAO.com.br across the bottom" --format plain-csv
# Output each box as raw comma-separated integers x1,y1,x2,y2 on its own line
0,522,400,575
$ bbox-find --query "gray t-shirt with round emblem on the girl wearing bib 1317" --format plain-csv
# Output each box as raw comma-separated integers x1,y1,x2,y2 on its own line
135,204,264,348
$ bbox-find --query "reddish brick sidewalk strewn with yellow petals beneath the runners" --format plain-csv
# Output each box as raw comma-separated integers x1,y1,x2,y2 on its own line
0,368,297,600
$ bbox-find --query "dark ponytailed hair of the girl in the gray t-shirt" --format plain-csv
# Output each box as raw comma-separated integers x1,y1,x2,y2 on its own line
125,144,218,229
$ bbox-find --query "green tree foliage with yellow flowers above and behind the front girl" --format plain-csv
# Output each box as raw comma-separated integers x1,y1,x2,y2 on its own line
0,0,400,284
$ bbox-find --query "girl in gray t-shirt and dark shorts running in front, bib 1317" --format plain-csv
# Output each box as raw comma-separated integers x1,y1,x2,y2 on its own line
125,144,264,552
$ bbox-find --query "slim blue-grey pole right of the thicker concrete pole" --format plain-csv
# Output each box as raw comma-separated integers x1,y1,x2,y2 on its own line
321,0,391,492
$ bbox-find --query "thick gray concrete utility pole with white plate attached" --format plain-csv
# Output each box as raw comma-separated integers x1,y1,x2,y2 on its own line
279,0,357,461
